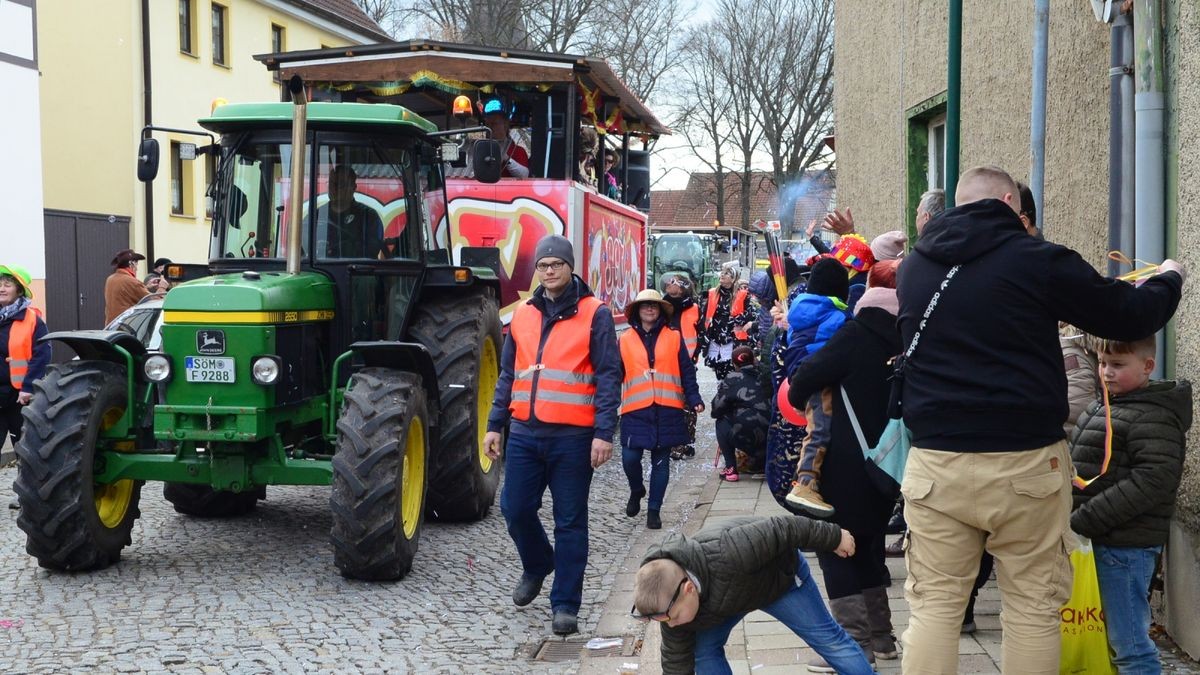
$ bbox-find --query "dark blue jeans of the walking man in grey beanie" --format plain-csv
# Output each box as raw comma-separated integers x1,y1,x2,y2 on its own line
500,434,592,613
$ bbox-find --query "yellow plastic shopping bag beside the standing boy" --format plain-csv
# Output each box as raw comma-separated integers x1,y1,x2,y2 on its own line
1058,539,1117,675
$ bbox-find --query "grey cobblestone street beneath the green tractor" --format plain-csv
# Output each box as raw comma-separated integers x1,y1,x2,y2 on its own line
0,368,715,673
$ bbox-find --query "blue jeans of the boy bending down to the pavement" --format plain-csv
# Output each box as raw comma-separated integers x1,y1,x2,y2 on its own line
696,554,875,675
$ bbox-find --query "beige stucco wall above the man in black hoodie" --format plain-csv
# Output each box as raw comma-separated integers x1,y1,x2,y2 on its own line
834,0,1109,265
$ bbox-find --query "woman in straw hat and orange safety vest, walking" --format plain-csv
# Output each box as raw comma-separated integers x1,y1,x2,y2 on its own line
618,289,704,530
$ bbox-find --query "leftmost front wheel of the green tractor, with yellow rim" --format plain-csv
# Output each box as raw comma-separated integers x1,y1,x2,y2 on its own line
13,360,142,572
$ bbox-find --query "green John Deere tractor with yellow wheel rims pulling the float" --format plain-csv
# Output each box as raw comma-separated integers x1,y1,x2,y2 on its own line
14,78,500,580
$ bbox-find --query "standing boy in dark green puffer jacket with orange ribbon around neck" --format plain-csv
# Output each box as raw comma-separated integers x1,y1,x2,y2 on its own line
1070,335,1192,674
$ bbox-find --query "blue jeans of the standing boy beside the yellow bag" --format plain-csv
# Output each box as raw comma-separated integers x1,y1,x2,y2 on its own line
1093,544,1163,675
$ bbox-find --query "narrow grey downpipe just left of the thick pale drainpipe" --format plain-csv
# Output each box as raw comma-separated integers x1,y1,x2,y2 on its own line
1108,12,1134,276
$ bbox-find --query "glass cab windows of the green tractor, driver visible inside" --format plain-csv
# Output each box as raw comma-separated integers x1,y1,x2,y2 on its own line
212,133,422,262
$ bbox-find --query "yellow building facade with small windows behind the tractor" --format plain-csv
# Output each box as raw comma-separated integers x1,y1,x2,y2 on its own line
37,0,389,328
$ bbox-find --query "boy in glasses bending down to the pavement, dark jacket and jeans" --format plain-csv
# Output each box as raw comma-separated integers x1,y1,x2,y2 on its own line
632,515,872,675
